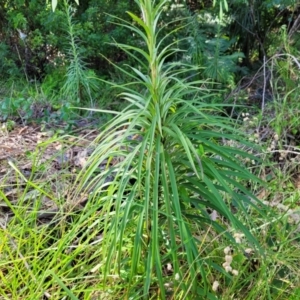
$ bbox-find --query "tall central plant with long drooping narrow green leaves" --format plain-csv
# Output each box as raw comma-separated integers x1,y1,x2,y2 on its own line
79,0,264,299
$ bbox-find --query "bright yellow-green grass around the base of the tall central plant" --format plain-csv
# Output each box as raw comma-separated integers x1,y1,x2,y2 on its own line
0,139,300,299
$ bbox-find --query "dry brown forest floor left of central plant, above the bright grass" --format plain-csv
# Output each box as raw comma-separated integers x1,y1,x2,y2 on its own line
0,123,99,220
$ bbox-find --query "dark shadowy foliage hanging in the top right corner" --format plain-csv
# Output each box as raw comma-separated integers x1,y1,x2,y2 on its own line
229,0,299,66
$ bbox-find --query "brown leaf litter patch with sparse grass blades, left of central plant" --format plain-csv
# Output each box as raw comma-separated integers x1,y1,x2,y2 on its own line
0,125,99,220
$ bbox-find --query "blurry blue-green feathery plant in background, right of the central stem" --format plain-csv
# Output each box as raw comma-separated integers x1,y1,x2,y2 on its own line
186,9,245,86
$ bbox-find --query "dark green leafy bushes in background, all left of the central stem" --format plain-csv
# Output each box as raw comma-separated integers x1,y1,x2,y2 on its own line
0,0,138,85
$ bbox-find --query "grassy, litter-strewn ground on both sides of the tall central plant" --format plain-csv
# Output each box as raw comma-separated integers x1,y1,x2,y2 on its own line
0,84,300,299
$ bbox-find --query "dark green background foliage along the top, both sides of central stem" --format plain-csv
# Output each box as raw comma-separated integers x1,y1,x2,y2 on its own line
0,0,298,85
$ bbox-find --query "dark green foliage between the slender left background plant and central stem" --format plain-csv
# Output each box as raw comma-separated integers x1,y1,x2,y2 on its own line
72,0,136,68
